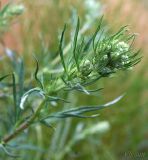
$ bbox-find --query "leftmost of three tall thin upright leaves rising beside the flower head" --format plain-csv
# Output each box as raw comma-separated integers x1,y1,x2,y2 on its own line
59,24,68,74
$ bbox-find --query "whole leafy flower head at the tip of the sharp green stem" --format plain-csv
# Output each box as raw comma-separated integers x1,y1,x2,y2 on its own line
60,20,141,89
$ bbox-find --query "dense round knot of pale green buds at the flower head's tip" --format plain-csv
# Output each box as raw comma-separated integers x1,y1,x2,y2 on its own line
93,39,132,76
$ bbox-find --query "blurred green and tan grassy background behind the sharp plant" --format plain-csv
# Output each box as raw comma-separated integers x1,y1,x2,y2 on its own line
0,0,148,160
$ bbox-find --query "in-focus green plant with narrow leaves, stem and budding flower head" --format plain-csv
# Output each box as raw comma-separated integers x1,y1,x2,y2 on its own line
0,1,141,159
